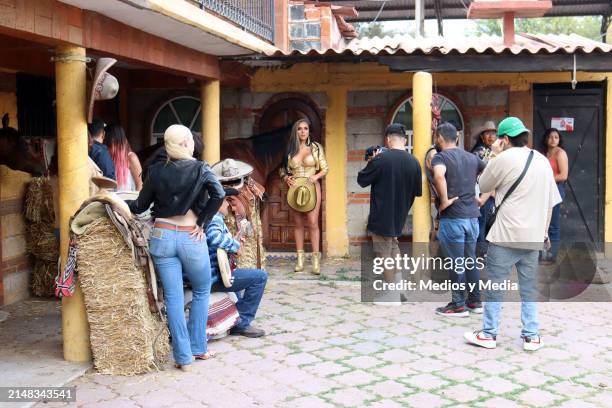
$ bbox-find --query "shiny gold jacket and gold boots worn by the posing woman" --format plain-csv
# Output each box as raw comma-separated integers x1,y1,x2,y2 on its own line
279,142,329,273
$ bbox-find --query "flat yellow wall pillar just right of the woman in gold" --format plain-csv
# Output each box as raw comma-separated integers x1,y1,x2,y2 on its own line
325,87,348,256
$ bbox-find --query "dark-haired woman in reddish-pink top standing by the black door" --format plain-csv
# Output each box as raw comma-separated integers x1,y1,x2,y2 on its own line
540,129,569,262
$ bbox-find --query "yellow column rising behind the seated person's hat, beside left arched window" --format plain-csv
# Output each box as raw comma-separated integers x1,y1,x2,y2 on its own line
201,79,221,166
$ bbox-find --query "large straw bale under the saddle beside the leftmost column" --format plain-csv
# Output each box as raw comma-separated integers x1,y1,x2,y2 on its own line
77,217,170,375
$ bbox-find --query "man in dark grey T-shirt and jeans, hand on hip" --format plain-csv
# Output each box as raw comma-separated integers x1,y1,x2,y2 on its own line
431,123,485,316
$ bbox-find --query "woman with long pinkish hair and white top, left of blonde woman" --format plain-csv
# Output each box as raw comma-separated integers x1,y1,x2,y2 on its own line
104,124,142,192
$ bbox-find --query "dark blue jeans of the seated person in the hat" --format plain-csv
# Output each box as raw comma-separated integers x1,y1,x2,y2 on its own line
213,269,268,330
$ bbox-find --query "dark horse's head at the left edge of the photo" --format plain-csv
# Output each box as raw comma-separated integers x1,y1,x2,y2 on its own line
0,113,45,176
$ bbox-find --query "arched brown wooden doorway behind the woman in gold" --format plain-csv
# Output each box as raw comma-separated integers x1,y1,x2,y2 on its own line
254,95,323,252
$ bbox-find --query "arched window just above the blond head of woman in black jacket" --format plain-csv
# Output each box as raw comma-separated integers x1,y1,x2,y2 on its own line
151,96,202,145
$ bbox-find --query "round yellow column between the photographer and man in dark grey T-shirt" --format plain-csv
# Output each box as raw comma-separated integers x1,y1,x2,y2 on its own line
412,72,432,242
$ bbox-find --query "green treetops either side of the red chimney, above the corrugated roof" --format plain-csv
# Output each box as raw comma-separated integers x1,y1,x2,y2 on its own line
476,16,601,41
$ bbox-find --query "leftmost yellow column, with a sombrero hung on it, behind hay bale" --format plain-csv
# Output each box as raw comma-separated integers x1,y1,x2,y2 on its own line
55,46,91,361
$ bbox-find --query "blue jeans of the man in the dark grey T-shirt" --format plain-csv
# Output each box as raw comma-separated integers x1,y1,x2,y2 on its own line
438,218,480,307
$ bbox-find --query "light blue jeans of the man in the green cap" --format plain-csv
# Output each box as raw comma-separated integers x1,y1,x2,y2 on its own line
482,244,539,337
